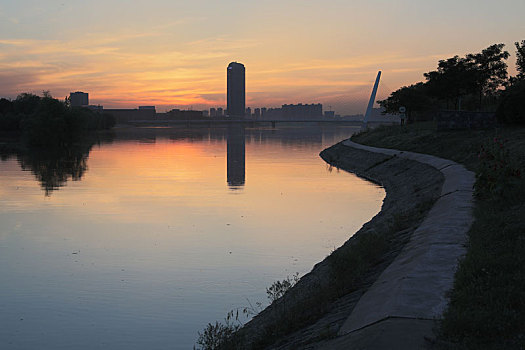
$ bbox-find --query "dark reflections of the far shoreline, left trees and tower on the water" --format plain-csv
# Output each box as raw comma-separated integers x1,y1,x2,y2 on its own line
0,124,368,196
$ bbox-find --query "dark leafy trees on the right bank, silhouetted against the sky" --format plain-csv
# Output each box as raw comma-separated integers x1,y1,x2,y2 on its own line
378,40,525,123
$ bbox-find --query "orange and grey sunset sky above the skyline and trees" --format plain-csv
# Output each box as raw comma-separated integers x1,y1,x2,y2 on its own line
0,0,525,115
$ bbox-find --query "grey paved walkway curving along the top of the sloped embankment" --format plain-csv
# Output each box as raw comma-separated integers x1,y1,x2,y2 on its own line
339,140,474,349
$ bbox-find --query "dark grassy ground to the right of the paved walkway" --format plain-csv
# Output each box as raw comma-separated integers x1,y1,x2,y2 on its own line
353,123,525,349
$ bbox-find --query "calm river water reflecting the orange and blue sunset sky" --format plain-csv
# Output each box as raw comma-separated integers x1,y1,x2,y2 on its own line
0,125,384,349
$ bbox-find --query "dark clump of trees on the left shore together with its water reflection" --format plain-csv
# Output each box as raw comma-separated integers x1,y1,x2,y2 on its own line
0,92,115,196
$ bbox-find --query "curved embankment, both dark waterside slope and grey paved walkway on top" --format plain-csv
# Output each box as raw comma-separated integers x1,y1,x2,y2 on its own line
240,143,454,349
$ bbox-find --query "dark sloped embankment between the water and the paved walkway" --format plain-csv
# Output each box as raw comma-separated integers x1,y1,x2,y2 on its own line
238,139,443,349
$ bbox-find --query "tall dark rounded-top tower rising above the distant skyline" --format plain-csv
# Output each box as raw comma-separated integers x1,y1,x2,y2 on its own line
226,62,246,117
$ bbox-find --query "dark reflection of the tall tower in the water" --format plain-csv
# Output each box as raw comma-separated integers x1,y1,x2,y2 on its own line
226,124,246,190
